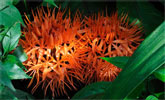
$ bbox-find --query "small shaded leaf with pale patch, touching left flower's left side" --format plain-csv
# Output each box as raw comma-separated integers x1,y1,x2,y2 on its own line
13,46,28,62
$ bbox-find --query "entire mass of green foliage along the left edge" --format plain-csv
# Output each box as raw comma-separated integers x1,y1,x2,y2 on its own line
0,0,31,100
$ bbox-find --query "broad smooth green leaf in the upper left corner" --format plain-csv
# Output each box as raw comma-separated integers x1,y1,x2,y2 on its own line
0,4,24,27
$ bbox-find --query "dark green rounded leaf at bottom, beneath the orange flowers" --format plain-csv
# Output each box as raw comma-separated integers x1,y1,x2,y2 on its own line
72,82,111,99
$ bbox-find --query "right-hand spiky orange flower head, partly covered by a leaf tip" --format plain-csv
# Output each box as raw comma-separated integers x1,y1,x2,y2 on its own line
84,12,143,83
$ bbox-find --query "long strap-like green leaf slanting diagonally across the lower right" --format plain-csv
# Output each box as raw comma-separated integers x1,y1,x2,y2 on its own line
104,22,165,99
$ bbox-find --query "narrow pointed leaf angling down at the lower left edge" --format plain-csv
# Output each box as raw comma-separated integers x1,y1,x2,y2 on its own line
0,62,15,91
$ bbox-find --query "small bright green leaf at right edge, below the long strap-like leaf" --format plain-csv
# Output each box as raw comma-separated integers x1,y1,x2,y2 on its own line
154,66,165,82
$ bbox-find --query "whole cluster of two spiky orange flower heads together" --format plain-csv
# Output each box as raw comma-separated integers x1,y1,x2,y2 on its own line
19,8,142,96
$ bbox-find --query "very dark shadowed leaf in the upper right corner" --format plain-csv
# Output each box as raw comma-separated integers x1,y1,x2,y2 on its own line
117,0,164,35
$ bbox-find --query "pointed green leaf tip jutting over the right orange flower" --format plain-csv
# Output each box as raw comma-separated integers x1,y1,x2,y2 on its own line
100,56,129,68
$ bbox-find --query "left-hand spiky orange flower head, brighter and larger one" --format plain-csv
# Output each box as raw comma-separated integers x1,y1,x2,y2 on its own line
20,7,83,96
